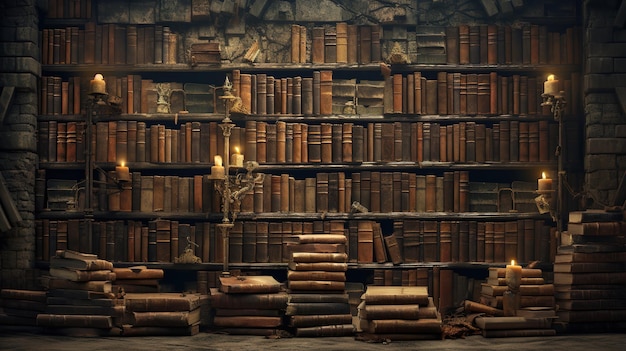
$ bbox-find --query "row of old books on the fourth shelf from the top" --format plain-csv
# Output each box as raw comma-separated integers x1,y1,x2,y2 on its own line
38,171,537,215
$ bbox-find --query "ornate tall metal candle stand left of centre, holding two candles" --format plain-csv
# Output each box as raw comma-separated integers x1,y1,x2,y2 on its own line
213,77,265,276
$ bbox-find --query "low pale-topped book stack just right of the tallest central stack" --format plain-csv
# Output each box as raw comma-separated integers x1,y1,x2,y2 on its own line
358,285,442,341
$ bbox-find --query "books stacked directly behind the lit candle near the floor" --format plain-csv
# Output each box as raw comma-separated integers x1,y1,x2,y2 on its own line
480,267,556,318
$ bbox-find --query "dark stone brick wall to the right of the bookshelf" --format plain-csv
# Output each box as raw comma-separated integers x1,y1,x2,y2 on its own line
584,0,626,207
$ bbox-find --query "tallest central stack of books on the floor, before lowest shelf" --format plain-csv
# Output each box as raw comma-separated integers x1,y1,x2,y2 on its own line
286,234,354,337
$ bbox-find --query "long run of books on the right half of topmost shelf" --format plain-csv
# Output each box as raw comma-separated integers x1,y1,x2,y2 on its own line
291,22,582,65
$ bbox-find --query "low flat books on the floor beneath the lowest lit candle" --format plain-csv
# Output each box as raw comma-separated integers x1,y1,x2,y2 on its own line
474,316,556,338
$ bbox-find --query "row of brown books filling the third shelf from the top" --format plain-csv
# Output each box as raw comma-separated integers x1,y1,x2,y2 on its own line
38,120,558,164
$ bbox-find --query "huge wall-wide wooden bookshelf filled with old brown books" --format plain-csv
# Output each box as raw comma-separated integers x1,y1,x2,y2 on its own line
37,1,581,308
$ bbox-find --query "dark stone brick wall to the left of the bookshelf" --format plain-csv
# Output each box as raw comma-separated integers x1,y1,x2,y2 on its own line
0,0,41,288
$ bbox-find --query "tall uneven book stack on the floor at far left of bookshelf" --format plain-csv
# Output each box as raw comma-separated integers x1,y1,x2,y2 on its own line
37,250,125,336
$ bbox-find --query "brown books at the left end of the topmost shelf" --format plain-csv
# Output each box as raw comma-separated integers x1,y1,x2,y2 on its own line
41,22,179,65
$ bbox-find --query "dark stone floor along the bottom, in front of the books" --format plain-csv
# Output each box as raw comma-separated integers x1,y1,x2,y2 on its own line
0,328,626,351
